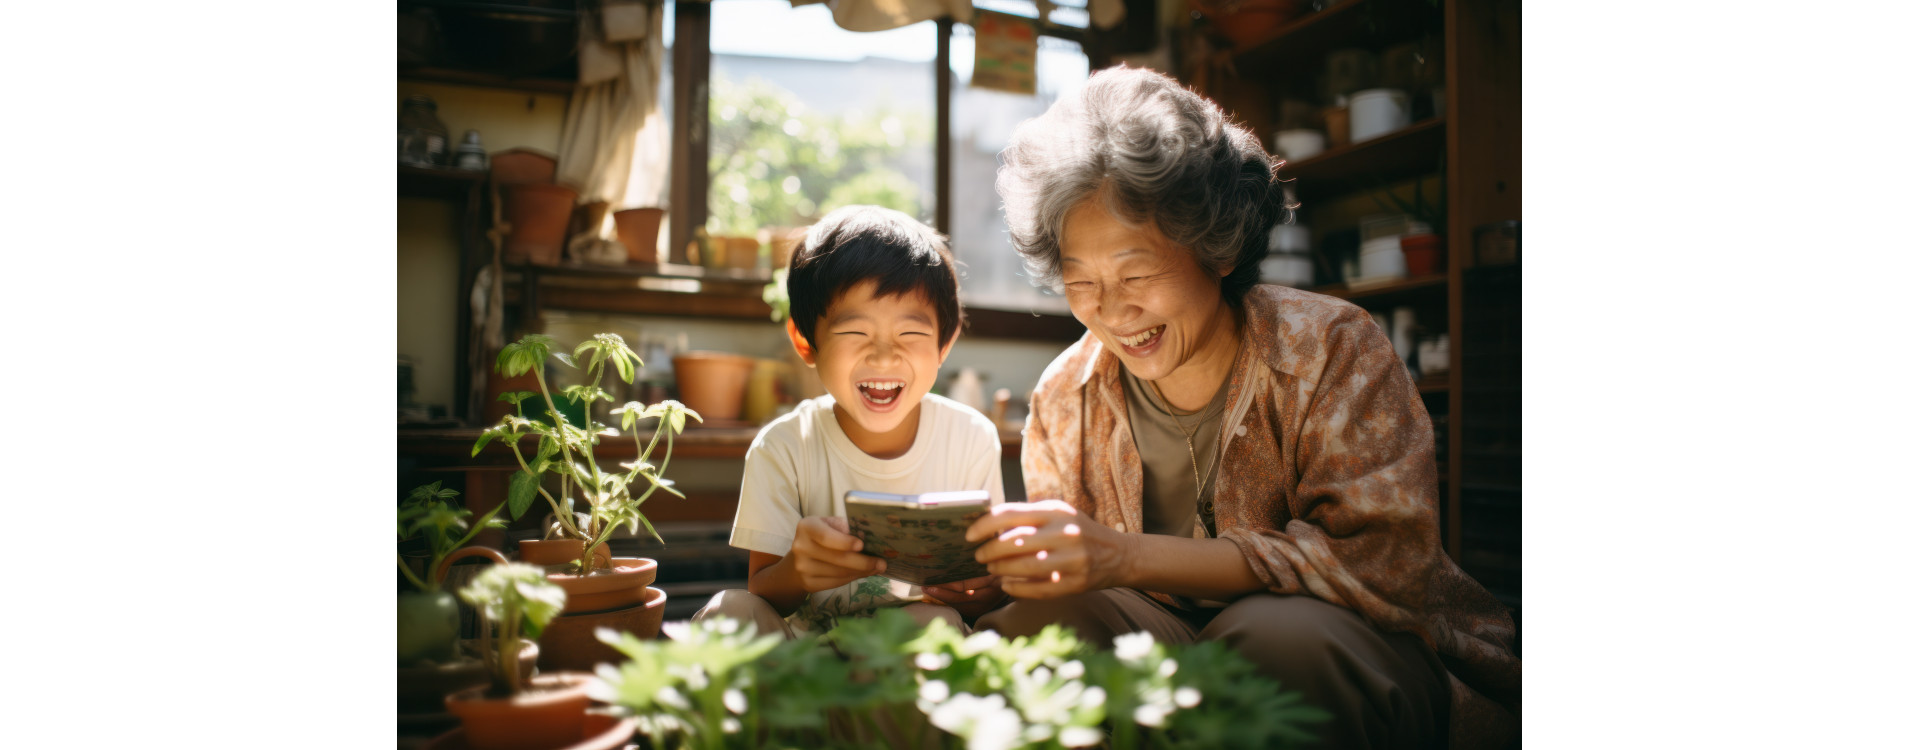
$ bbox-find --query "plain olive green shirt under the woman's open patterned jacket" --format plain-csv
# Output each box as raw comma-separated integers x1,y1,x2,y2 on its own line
1119,368,1227,537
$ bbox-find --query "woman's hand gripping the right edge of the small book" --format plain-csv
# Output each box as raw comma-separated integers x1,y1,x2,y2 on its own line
966,501,1129,598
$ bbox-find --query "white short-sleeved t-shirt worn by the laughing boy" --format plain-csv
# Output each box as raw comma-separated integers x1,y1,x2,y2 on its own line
730,393,1006,631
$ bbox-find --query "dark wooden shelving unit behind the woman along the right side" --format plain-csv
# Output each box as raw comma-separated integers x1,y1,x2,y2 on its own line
1167,0,1521,606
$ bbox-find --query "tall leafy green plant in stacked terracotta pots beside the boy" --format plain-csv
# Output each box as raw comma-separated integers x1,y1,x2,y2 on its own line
474,334,701,669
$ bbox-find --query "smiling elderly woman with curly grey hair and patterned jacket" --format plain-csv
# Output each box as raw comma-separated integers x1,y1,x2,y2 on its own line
935,67,1521,748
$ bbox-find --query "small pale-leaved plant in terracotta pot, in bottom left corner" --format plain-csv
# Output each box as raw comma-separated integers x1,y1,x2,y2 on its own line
432,562,634,750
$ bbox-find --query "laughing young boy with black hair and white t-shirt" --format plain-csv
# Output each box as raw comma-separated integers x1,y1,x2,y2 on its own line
693,205,1004,637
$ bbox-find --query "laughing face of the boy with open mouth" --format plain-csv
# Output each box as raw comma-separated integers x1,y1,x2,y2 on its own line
801,280,952,453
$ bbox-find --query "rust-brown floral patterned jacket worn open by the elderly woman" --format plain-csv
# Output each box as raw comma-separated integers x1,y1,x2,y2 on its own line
1020,286,1521,748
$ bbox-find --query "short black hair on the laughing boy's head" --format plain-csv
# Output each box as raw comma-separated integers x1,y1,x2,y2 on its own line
787,205,962,349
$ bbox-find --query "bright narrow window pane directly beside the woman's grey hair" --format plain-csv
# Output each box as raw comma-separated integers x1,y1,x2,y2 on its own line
952,26,1087,313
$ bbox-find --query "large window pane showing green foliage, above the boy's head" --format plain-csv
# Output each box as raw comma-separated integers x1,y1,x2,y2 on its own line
707,0,935,236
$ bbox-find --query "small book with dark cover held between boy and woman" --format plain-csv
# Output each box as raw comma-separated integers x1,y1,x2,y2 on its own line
847,489,993,587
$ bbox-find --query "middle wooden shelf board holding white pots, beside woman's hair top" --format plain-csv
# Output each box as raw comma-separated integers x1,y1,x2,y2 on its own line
1281,117,1446,198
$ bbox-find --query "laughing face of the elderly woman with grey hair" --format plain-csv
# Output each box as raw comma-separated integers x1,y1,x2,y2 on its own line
1060,199,1231,387
